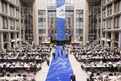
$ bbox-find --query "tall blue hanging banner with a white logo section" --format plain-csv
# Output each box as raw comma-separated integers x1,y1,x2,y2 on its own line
56,0,65,40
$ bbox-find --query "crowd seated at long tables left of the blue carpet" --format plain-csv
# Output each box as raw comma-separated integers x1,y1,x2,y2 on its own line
0,45,52,81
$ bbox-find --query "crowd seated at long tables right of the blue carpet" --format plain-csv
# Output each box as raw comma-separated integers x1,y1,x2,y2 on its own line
71,45,121,81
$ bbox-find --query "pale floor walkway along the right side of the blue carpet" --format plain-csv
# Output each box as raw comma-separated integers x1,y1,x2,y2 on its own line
69,54,88,81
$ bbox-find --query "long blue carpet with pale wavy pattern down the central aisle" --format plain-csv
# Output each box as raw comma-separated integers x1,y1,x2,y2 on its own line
46,46,73,81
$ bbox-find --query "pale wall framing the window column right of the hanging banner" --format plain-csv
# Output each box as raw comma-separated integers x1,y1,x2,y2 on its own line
74,0,88,44
